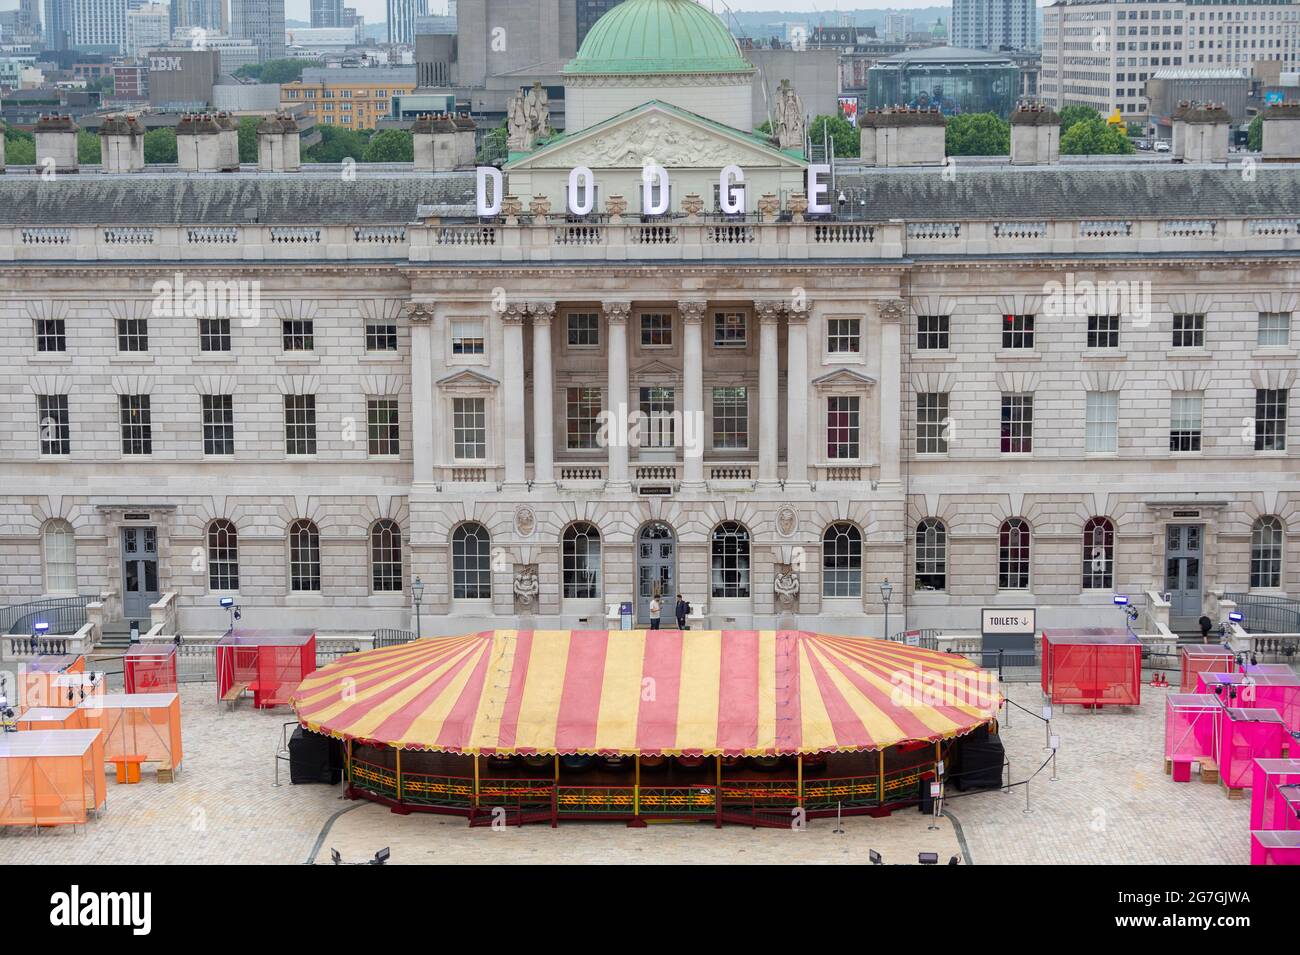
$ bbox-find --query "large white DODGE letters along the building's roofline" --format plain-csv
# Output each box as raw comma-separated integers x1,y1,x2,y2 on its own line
475,162,833,218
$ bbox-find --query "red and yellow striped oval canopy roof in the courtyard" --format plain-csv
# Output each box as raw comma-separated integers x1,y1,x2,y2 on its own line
291,630,1001,756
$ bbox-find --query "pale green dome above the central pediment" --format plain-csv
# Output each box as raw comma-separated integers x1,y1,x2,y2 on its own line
564,0,754,74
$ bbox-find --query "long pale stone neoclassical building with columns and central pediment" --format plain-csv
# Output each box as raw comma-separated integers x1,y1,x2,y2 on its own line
0,0,1300,634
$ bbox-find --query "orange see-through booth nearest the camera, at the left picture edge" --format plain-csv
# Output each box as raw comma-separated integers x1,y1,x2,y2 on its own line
0,729,107,826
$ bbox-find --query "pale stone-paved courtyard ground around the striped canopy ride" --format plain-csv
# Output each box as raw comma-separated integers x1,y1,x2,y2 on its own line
0,683,1249,865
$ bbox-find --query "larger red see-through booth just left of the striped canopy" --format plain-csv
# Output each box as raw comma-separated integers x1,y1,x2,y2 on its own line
217,630,316,707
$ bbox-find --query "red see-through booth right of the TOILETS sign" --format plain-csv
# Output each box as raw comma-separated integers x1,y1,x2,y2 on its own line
1043,628,1141,707
